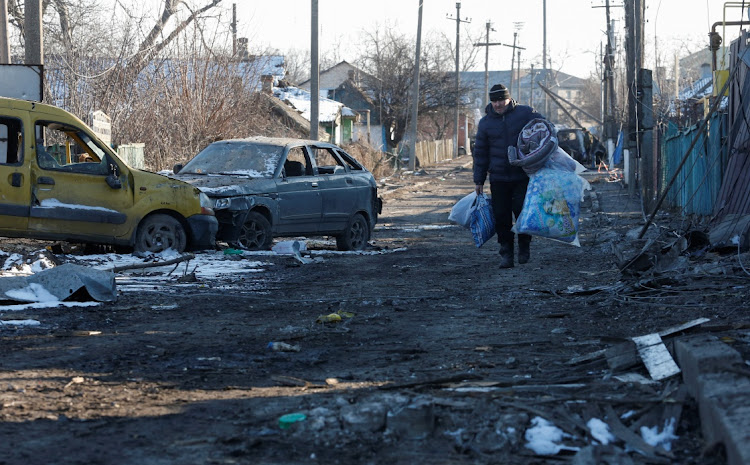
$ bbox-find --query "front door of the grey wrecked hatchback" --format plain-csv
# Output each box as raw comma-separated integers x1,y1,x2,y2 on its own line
274,146,322,234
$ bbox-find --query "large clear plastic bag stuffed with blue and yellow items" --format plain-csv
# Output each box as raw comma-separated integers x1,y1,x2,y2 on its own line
512,168,591,247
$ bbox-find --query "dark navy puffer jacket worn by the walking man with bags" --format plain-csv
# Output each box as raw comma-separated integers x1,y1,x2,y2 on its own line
473,100,544,185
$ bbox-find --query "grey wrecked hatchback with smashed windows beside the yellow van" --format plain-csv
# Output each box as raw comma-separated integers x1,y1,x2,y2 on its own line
173,137,382,250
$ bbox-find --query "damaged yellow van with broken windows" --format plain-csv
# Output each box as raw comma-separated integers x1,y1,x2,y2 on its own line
0,97,218,253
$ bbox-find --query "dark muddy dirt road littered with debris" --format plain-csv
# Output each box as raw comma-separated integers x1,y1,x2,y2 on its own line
0,157,748,465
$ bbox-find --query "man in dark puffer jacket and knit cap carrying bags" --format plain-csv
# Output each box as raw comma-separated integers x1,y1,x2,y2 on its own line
473,84,544,268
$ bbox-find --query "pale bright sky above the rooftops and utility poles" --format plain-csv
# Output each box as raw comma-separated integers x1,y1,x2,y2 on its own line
232,0,747,77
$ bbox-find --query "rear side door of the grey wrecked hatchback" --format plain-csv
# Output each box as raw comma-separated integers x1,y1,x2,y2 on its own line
310,146,366,232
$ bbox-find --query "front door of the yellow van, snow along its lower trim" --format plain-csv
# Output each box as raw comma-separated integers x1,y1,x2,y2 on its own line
29,121,135,238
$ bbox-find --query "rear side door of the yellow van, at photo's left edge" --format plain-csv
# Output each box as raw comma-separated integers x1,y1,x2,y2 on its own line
0,113,31,234
